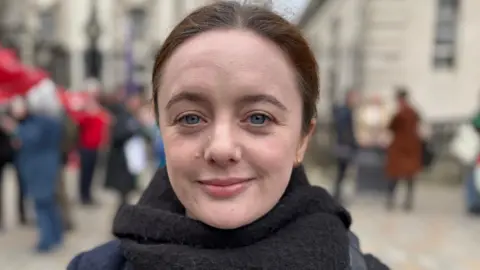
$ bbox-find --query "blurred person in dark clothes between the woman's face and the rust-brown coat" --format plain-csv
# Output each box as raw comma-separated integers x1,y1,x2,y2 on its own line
333,91,358,202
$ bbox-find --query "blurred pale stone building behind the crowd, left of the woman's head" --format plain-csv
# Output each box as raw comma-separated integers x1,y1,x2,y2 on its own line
0,0,208,90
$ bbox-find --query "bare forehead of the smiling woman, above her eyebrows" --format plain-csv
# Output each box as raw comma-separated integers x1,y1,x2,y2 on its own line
161,29,296,92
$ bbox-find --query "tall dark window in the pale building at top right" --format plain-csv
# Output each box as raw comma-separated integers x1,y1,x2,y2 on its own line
433,0,459,68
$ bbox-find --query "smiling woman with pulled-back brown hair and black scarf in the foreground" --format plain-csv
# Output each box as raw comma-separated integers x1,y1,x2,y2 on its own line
69,2,384,270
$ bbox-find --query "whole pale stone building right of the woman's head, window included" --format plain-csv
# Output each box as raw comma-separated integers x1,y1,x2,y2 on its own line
300,0,480,121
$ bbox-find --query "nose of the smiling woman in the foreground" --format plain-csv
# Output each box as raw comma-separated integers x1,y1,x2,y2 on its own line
204,124,241,167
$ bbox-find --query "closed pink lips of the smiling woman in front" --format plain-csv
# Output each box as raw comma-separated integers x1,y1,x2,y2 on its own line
199,178,252,199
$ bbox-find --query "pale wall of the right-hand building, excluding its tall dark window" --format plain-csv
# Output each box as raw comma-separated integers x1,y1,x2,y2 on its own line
304,0,480,120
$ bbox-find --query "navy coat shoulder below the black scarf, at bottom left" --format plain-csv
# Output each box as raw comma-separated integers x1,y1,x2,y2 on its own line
67,240,125,270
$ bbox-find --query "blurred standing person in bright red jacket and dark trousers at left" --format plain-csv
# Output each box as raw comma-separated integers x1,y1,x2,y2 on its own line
78,100,106,205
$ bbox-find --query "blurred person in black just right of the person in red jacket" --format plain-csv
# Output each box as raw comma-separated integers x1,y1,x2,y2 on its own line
105,97,142,205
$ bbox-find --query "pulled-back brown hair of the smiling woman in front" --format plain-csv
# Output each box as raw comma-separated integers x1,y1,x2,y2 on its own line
152,1,319,132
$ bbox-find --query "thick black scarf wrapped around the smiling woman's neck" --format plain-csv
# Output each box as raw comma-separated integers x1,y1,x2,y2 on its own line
113,167,351,270
